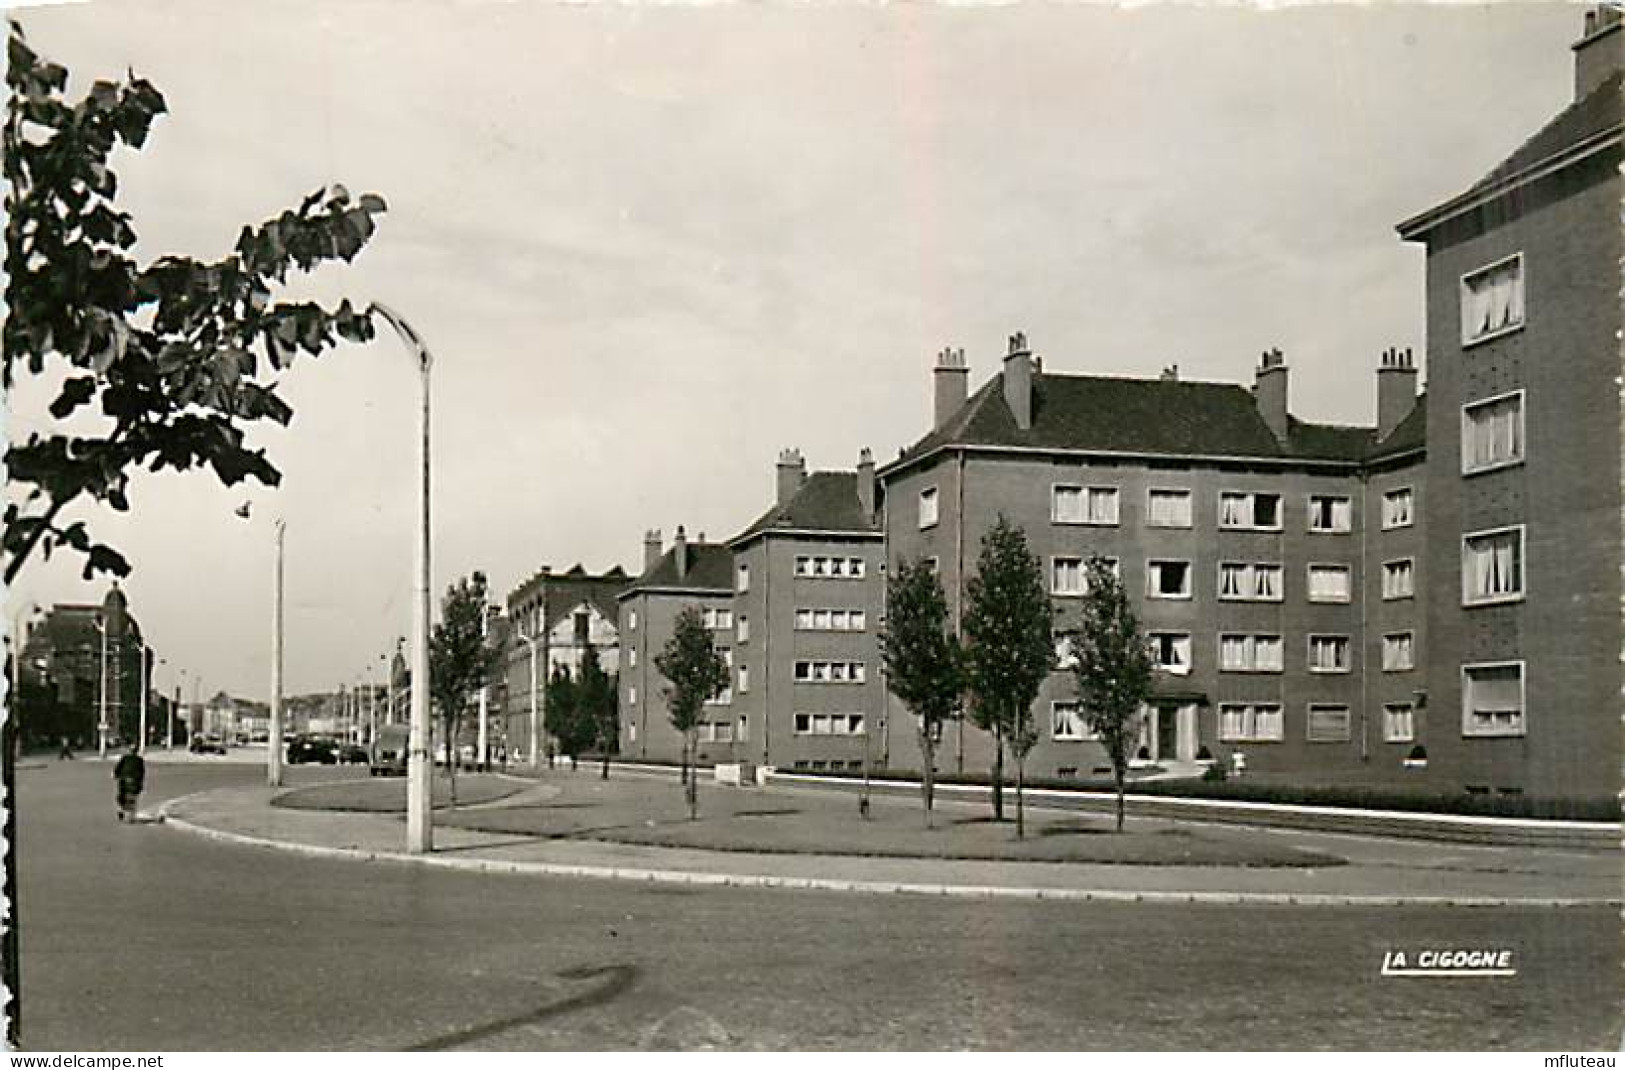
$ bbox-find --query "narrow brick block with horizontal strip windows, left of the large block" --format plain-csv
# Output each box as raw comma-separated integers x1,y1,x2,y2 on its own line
728,450,886,771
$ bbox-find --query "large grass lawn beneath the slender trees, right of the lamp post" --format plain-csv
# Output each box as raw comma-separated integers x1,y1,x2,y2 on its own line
439,768,1342,867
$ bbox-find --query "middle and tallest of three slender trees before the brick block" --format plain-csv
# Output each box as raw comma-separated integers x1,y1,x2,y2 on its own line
965,515,1055,837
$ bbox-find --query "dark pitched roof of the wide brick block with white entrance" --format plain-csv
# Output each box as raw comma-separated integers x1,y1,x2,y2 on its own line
889,372,1373,467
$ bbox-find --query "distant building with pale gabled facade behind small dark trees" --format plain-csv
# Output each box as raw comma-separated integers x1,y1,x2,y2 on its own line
503,564,632,761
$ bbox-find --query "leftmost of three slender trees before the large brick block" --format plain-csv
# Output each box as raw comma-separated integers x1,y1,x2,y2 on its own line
879,561,960,828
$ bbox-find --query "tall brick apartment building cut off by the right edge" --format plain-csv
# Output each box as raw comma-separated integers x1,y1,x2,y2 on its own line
1398,5,1625,795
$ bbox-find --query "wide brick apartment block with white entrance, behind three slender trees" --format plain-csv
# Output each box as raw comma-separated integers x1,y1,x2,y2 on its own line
878,333,1424,781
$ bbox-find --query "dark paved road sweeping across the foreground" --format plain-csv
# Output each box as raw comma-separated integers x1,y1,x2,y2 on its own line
20,761,1620,1050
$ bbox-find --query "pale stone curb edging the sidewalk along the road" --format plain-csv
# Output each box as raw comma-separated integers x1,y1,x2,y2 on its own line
158,792,1625,909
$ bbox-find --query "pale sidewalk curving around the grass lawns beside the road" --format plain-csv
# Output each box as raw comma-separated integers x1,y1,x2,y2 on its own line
163,784,1622,907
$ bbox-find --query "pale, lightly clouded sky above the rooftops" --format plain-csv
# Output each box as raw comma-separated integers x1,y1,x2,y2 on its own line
7,0,1583,699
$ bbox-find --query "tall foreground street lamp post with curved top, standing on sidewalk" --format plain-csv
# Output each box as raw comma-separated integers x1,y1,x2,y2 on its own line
371,302,434,854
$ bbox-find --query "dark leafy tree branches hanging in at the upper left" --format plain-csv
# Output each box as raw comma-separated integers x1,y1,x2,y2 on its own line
0,21,385,582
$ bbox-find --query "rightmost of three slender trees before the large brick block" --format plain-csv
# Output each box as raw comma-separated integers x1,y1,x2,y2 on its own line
1069,556,1152,833
